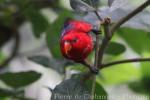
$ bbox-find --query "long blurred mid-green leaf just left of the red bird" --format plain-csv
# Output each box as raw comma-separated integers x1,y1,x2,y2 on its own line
46,10,72,58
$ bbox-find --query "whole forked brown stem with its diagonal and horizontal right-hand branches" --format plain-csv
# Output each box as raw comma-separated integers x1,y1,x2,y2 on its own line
83,0,150,73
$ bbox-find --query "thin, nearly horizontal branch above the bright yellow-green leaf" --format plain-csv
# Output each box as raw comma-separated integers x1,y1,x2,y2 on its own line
101,58,150,69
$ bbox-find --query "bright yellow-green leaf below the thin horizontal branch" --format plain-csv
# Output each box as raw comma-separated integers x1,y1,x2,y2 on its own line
98,64,141,85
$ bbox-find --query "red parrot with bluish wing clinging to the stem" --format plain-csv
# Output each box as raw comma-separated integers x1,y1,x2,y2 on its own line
60,19,98,73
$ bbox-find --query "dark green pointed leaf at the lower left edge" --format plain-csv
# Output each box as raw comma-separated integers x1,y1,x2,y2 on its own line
0,71,41,88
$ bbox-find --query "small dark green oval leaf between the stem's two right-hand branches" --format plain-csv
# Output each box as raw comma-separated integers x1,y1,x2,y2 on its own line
105,42,126,55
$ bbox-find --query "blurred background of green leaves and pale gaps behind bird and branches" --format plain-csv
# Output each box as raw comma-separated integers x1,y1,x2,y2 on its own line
0,0,150,100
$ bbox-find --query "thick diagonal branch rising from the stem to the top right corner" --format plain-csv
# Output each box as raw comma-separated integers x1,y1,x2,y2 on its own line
111,0,150,35
